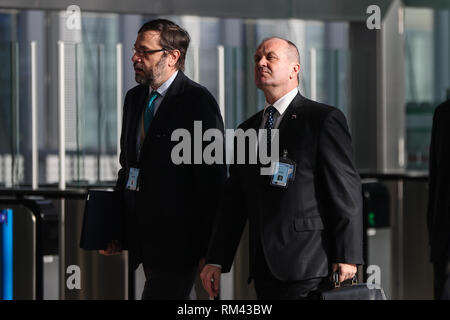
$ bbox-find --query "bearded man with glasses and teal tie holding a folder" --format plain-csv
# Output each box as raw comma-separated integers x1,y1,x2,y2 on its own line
100,19,226,300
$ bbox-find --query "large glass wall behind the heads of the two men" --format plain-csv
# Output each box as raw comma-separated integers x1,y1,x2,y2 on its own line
0,10,349,188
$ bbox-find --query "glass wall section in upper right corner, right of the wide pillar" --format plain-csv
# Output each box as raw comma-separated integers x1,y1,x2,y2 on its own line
405,8,450,170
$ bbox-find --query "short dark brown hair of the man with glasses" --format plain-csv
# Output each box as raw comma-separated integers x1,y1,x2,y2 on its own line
138,19,191,71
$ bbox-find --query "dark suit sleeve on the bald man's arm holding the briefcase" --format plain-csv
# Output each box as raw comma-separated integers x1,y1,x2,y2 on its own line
318,109,364,264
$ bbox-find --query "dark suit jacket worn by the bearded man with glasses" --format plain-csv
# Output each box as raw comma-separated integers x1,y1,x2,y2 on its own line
116,71,226,270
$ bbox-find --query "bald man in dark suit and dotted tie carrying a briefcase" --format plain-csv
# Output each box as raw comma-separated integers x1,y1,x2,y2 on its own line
201,38,363,299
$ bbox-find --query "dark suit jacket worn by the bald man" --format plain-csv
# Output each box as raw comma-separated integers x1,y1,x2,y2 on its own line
207,94,363,281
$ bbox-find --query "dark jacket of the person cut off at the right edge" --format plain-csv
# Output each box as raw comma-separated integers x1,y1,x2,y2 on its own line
427,100,450,262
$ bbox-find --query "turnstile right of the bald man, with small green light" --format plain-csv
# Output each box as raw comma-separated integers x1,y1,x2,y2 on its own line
361,172,433,300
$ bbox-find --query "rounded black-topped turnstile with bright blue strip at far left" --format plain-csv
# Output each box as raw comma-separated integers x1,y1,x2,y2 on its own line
0,198,58,300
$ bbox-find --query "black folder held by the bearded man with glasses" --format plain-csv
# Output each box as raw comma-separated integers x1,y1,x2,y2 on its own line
80,190,124,250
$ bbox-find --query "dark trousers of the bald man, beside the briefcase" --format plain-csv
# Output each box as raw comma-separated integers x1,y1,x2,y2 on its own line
254,242,330,300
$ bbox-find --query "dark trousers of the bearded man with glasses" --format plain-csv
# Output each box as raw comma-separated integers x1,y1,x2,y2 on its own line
142,267,198,300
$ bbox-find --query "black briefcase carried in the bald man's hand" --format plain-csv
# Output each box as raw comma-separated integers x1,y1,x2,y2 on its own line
321,273,386,300
